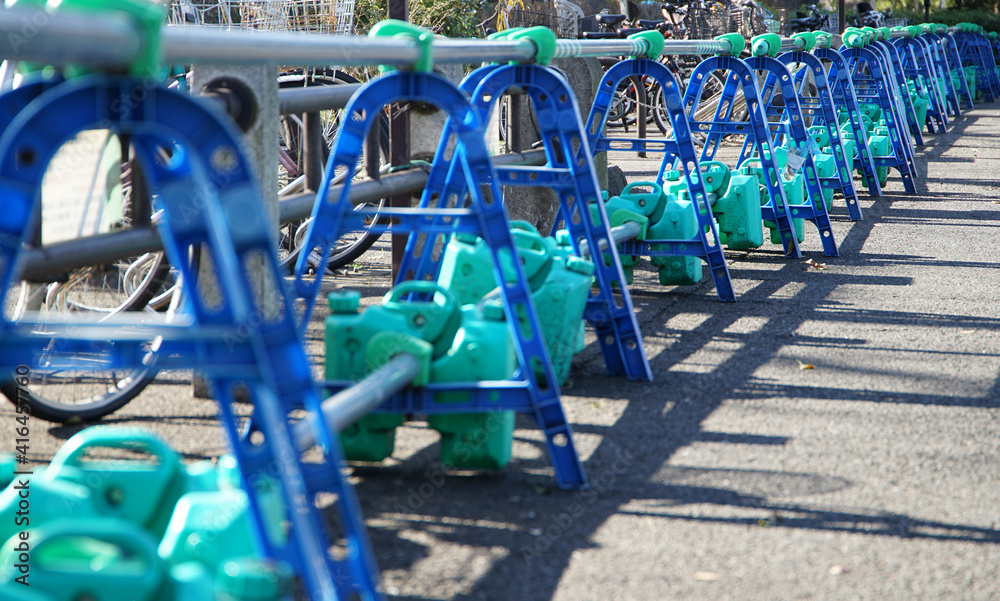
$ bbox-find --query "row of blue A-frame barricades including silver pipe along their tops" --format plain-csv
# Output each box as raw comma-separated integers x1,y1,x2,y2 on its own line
7,9,1000,601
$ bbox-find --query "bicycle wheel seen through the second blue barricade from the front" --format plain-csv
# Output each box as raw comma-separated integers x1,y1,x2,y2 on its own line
278,69,389,272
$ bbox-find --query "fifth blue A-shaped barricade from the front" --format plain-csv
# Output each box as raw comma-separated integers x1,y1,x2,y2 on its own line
683,56,802,259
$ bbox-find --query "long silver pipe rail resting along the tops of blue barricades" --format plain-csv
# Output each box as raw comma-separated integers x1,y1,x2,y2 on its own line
0,8,730,68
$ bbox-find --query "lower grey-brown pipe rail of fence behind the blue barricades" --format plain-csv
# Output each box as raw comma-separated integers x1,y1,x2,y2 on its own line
20,150,545,282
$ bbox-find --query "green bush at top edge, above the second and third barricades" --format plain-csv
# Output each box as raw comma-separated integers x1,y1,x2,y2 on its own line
354,0,490,38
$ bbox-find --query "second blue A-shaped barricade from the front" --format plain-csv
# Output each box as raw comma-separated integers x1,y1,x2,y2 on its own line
295,71,587,488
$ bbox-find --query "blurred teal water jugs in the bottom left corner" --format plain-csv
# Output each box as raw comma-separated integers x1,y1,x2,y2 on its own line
0,427,293,601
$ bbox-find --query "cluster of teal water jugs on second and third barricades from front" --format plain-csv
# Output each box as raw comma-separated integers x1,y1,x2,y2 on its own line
326,222,594,469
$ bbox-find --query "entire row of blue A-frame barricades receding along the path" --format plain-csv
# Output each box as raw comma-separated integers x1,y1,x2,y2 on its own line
0,16,1000,599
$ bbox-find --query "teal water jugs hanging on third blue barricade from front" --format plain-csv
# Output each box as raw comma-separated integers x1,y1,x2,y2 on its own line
438,219,592,384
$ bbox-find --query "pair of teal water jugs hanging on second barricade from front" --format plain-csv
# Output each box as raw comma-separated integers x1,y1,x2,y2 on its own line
326,281,517,468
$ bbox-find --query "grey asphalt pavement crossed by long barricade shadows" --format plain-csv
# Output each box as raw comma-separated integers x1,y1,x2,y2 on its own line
0,107,1000,601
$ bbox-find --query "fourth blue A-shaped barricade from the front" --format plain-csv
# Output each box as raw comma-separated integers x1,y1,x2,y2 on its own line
586,58,736,301
